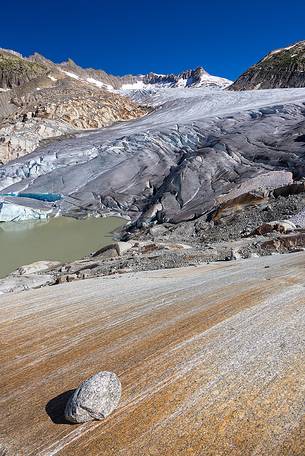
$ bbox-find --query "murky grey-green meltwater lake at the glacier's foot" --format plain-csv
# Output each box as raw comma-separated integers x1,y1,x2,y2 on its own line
0,217,126,278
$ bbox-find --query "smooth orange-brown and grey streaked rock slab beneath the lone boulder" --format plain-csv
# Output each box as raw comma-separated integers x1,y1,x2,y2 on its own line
0,253,305,456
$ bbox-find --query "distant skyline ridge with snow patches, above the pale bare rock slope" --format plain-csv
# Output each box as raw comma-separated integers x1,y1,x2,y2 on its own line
0,49,232,92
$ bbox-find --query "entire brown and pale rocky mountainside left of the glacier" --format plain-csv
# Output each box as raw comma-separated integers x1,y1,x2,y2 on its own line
0,49,148,163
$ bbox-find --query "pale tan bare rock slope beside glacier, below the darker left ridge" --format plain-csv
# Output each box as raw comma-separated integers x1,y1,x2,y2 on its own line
0,80,147,163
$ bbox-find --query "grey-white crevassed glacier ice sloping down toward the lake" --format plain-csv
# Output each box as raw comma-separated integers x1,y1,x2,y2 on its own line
0,88,305,220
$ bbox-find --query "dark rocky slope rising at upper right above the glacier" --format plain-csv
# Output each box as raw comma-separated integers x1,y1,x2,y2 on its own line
229,41,305,90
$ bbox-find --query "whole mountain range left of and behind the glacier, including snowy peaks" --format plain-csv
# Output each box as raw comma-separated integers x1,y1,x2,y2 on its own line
0,48,230,163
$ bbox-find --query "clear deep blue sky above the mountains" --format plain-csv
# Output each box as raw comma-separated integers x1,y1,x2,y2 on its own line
0,0,305,79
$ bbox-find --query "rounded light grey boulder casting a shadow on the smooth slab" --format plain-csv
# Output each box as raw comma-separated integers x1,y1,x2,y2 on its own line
65,372,121,423
